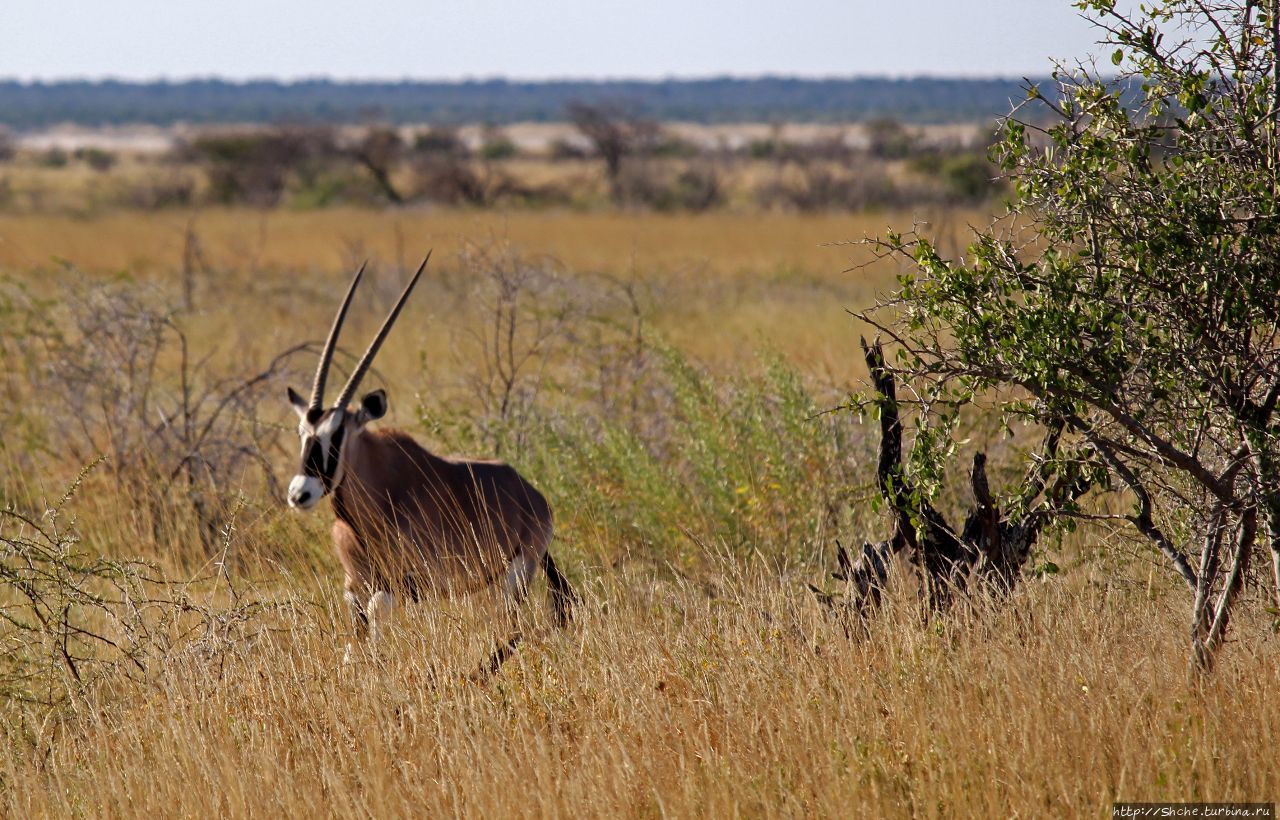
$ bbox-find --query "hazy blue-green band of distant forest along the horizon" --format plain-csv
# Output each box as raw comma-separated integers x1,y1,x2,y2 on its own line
0,77,1049,129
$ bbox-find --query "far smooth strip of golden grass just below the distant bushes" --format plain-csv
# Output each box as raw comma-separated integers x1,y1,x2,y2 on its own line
0,209,921,279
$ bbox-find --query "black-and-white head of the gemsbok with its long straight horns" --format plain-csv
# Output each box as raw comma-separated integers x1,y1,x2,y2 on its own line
288,253,431,509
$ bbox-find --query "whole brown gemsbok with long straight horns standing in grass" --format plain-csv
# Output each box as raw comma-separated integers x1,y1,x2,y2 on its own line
288,253,576,673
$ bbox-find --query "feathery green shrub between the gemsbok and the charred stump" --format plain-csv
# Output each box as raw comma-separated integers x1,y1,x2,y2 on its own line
421,349,874,572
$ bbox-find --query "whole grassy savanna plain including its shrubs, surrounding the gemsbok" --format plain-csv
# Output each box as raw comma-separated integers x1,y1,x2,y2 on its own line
0,206,1280,817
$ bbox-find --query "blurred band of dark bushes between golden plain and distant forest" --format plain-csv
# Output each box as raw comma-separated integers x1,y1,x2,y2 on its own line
0,102,1004,211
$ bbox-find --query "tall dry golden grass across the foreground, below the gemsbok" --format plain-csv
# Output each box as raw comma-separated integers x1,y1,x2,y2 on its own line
0,567,1280,817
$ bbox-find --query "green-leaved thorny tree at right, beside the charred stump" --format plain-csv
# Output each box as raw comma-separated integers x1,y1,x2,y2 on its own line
864,0,1280,670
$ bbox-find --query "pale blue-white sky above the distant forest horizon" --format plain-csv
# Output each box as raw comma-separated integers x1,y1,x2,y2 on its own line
0,0,1111,79
